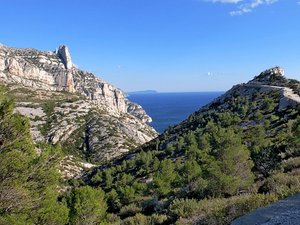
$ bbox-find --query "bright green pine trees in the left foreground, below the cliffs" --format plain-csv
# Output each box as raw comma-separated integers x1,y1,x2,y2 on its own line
0,85,68,224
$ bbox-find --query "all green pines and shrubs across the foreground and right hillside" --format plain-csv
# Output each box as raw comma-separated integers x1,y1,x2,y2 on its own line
0,75,300,225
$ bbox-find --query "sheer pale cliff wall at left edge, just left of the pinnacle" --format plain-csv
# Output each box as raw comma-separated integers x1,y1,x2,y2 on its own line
0,46,72,91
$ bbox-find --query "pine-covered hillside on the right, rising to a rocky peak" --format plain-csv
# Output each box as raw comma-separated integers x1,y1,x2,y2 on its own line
83,67,300,224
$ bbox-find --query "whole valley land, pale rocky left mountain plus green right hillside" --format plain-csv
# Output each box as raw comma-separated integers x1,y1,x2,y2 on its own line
0,46,300,225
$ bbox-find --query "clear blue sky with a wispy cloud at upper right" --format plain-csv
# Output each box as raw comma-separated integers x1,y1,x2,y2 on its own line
0,0,300,92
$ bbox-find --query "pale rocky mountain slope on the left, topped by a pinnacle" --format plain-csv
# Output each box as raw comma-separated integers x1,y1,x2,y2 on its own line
0,46,157,171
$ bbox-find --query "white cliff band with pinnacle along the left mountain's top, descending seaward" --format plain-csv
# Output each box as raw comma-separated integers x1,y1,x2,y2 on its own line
0,45,151,123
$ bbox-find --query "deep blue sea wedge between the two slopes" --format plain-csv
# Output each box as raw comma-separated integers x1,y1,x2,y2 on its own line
128,92,224,133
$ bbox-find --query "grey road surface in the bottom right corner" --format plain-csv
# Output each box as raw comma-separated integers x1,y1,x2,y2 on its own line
231,194,300,225
